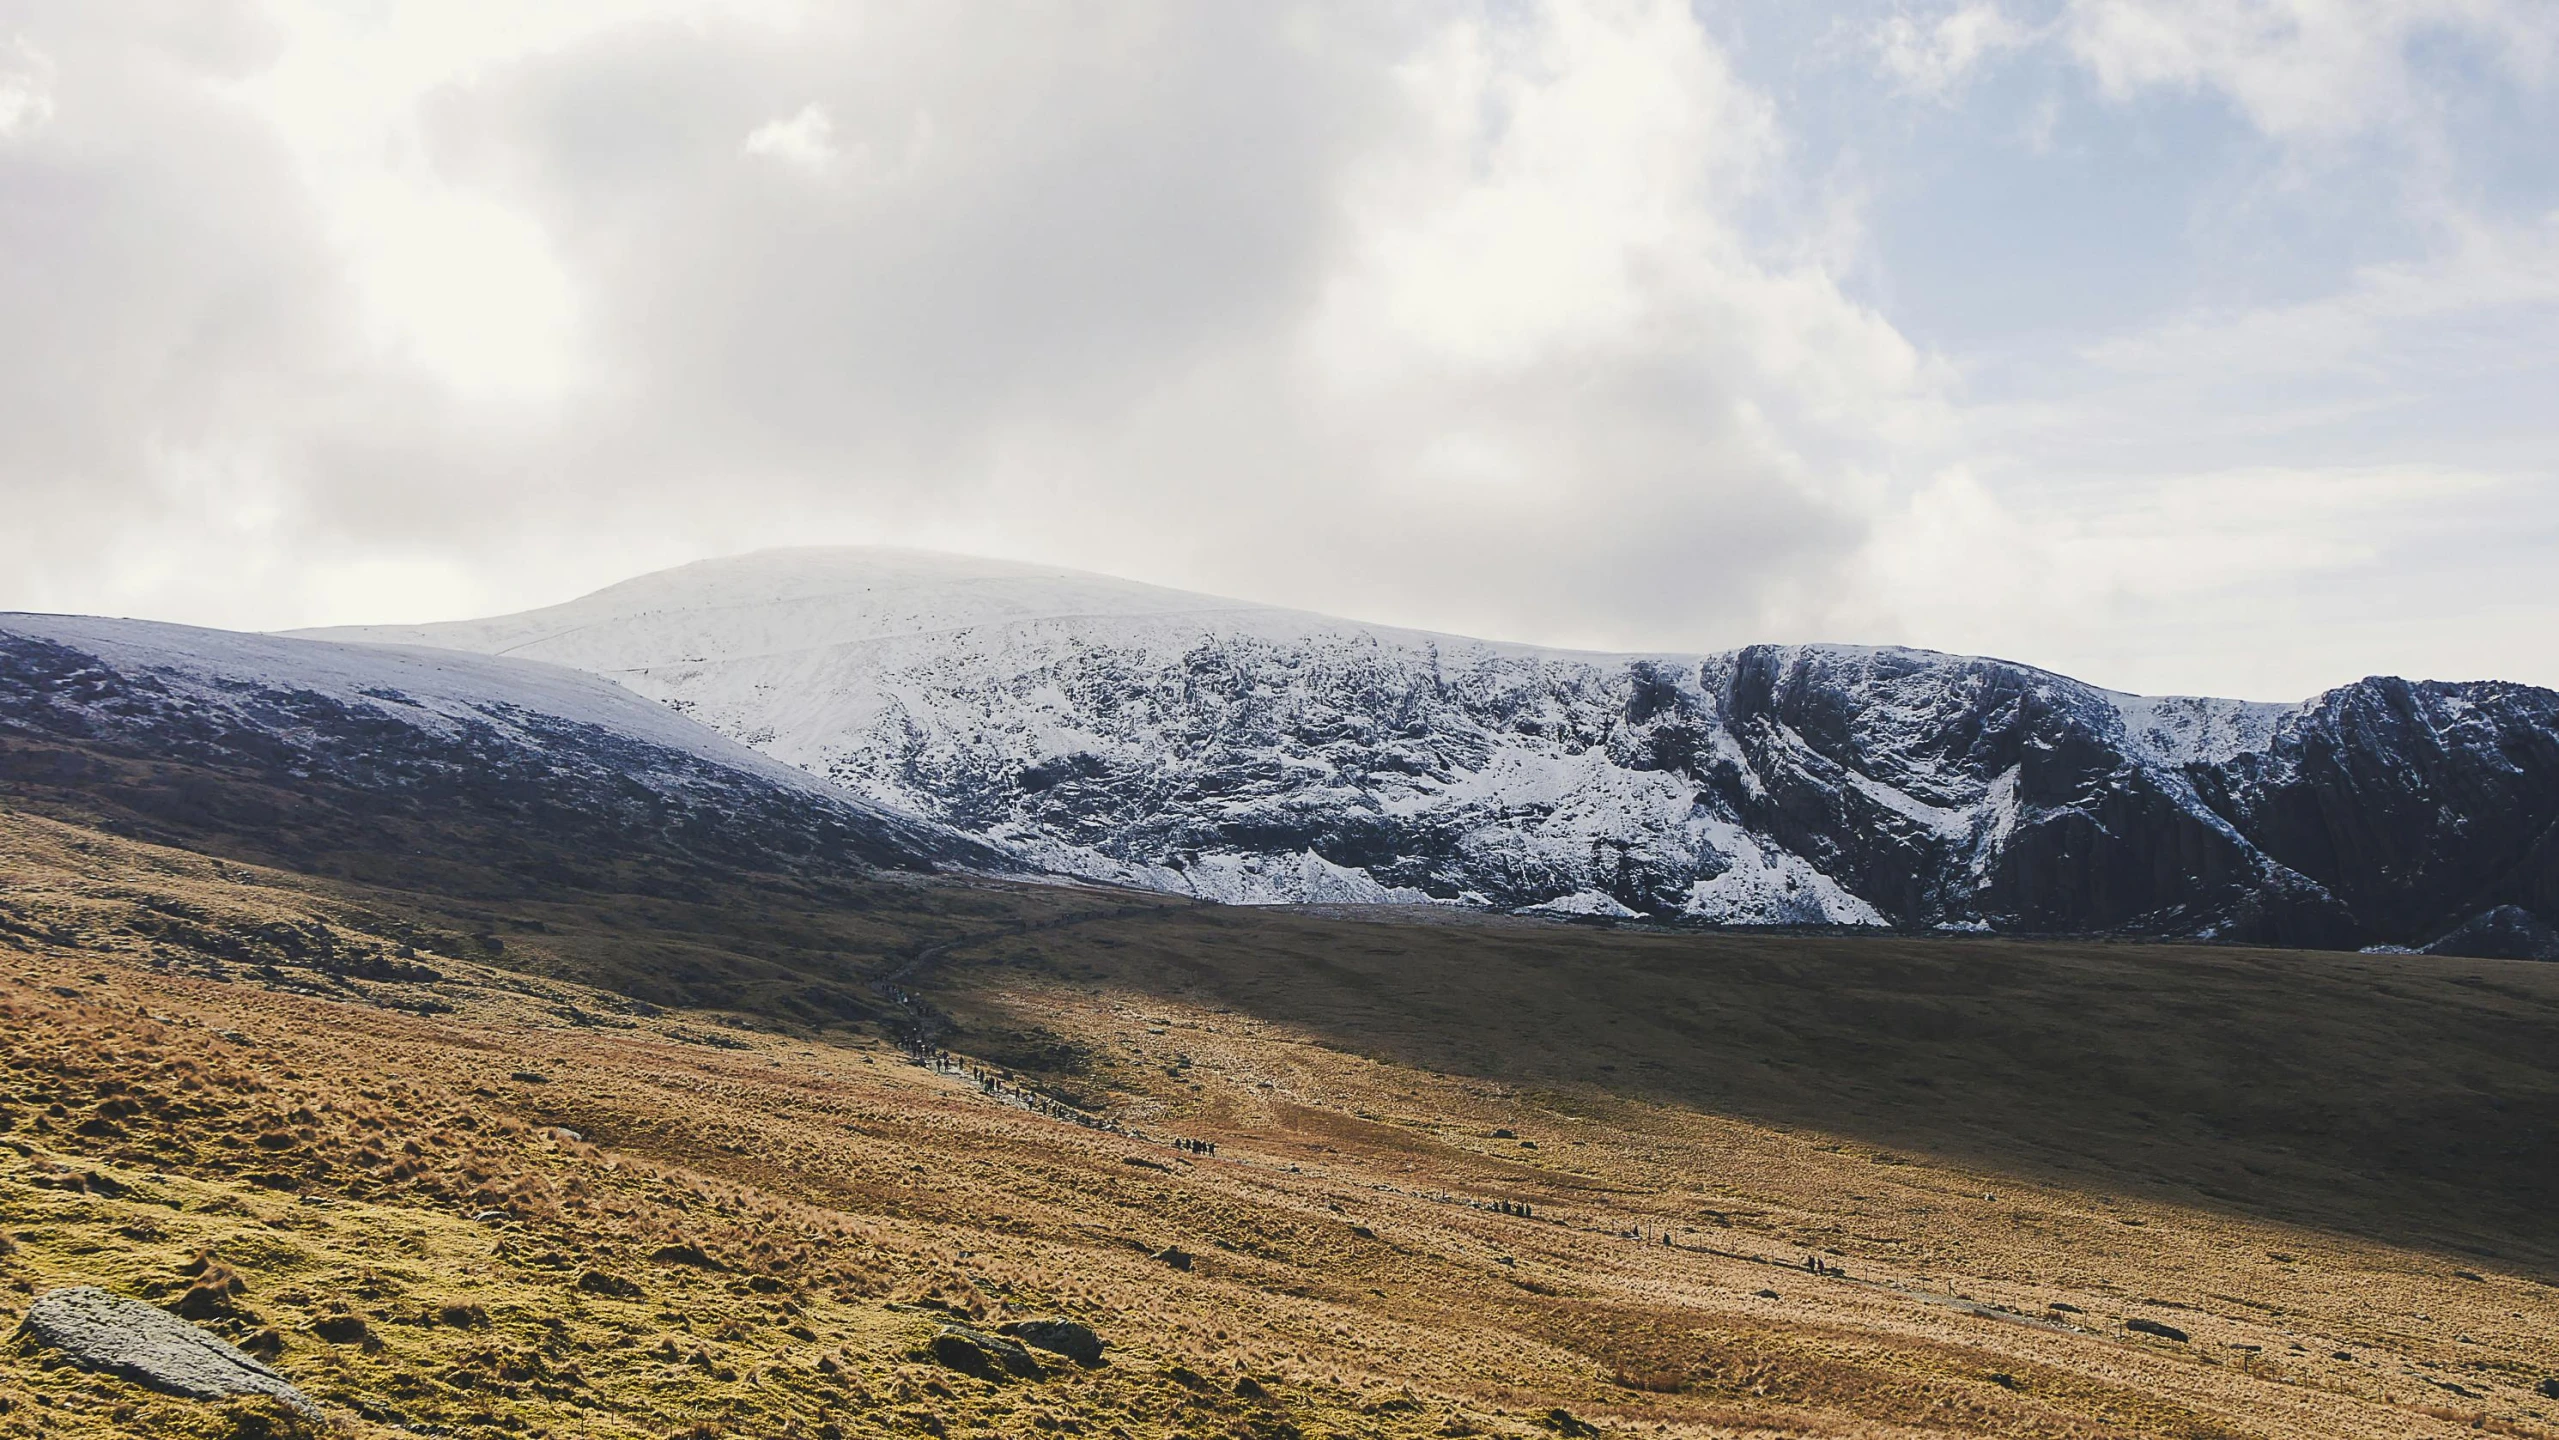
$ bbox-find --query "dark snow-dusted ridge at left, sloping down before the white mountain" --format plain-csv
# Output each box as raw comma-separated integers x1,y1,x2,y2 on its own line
0,614,1018,870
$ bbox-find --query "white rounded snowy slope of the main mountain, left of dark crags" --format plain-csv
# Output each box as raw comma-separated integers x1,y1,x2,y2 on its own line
315,550,1878,923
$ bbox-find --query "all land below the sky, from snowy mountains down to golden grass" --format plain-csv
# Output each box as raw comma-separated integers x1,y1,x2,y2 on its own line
15,552,2559,1440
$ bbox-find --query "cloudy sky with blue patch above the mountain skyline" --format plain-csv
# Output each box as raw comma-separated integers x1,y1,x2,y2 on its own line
0,0,2559,701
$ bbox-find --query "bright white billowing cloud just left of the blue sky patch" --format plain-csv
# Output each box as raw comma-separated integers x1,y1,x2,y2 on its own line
1042,5,1945,645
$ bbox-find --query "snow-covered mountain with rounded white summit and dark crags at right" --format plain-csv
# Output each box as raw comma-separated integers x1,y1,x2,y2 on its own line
312,550,2559,944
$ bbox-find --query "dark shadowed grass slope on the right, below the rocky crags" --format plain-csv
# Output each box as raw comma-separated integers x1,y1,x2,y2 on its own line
921,908,2559,1274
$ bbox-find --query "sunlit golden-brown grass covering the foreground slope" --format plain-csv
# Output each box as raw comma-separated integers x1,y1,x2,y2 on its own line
0,816,2559,1440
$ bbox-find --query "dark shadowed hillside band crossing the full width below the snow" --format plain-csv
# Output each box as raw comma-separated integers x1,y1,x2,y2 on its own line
0,705,2559,1253
